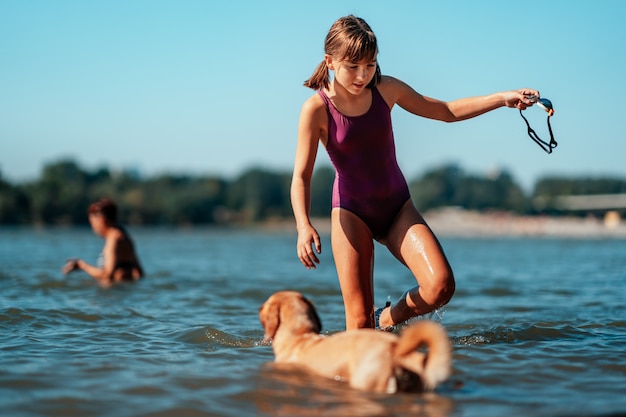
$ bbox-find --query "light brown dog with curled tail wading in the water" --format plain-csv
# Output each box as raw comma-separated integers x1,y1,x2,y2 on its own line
259,291,451,393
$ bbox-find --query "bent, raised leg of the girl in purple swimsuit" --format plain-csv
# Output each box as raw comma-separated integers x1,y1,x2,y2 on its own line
380,200,455,327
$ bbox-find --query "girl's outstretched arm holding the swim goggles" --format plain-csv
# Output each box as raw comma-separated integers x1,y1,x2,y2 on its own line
380,76,539,122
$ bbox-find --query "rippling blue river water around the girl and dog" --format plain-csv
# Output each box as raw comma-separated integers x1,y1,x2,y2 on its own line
0,228,626,417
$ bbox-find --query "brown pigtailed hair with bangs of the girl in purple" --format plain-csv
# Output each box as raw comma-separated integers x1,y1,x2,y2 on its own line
304,15,381,90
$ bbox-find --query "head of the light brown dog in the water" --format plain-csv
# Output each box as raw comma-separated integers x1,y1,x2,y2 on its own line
259,291,322,341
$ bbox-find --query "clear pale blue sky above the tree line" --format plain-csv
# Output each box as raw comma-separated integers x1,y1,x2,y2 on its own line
0,0,626,187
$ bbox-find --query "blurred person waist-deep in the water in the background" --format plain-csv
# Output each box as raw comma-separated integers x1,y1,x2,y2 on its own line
62,198,143,286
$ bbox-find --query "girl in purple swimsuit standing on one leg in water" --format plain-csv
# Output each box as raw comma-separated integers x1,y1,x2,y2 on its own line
291,16,539,329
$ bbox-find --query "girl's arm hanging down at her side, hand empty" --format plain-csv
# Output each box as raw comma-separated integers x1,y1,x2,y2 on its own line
291,94,326,268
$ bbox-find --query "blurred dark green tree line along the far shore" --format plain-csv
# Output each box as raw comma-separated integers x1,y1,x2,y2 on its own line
0,160,626,225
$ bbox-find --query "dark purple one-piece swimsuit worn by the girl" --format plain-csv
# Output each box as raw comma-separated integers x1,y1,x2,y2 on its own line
318,87,410,239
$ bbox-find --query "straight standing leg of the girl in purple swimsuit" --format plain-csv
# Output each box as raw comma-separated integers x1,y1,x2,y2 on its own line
331,208,374,330
